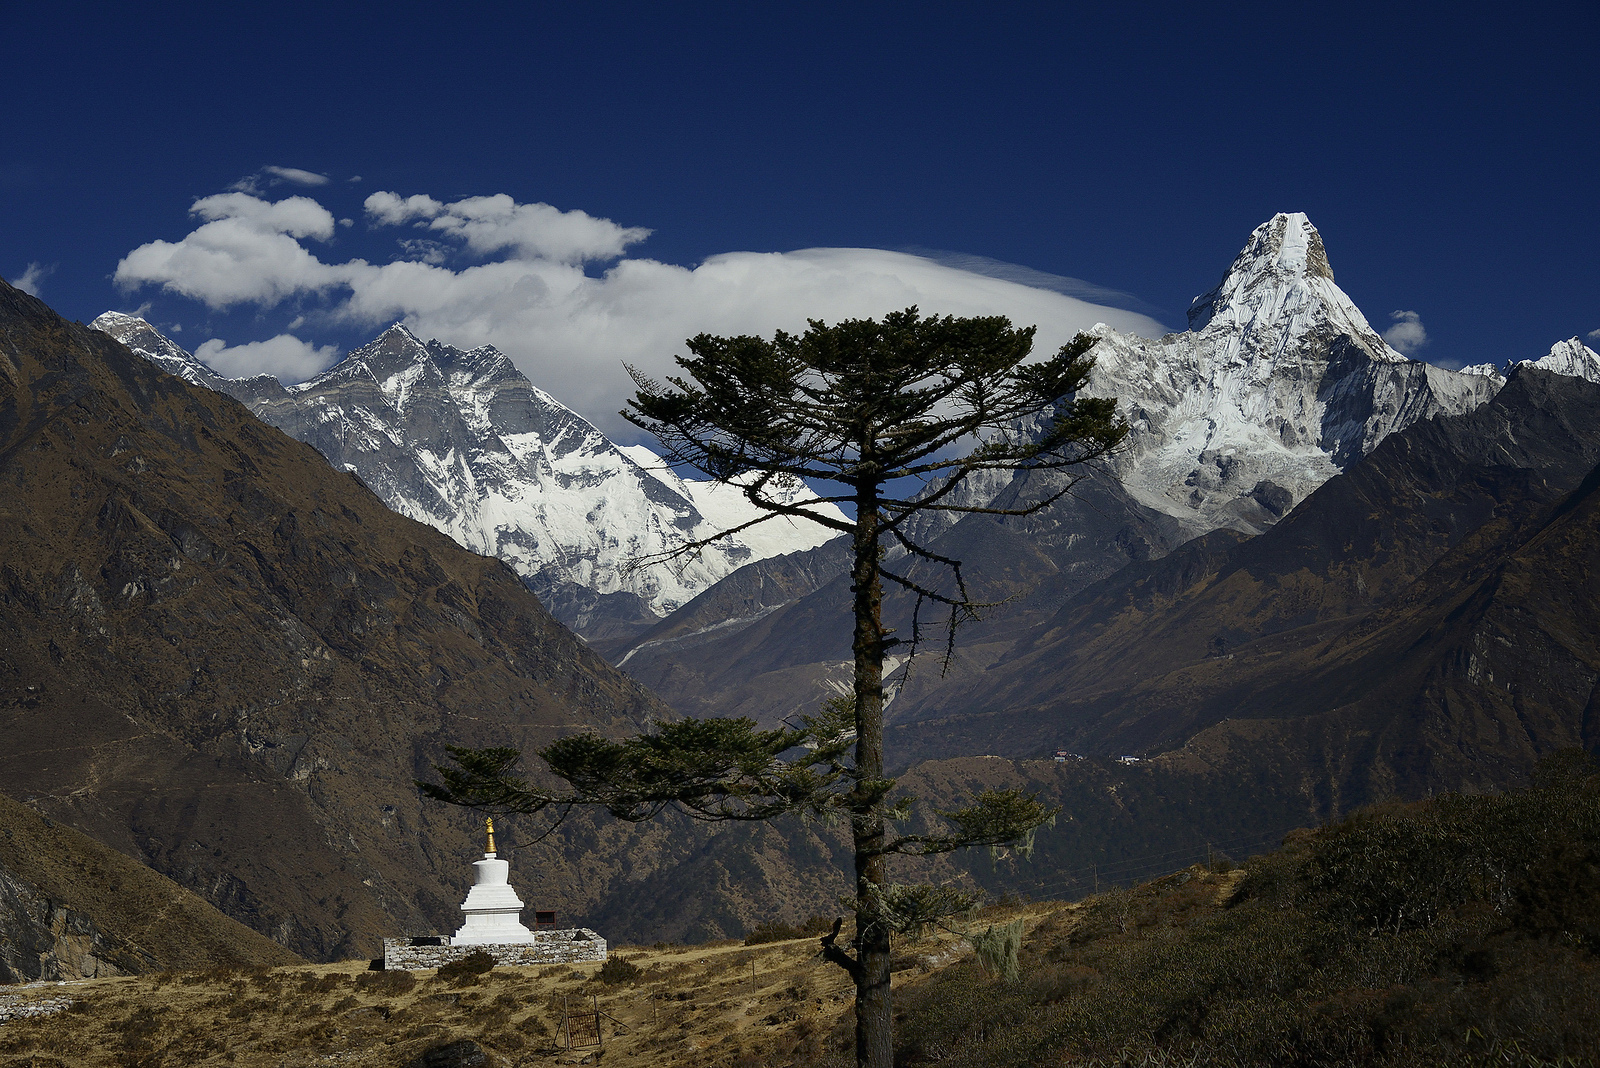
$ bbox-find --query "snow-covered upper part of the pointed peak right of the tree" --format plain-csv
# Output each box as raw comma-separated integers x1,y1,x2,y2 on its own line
1088,213,1499,532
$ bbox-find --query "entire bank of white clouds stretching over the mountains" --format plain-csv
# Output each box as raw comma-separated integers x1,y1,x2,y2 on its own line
115,192,1163,433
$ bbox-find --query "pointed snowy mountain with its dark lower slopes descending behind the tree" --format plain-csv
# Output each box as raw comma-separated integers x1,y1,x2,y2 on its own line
605,214,1523,719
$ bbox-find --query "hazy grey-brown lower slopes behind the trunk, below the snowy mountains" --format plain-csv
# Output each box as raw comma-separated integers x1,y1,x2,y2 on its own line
618,473,1184,723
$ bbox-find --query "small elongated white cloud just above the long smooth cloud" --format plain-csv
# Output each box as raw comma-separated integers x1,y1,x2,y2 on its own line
366,192,650,264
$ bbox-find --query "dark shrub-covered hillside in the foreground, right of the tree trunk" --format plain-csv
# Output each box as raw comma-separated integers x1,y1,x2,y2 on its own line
898,763,1600,1068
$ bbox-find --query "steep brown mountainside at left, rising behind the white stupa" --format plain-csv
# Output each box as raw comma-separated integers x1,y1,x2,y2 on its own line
0,279,661,958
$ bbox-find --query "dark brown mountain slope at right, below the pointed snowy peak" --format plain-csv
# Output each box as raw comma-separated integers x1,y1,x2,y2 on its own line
894,369,1600,807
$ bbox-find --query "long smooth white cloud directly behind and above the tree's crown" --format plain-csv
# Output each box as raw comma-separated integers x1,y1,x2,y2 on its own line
328,248,1165,435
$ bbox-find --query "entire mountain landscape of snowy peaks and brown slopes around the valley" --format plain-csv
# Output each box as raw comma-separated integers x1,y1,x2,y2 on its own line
0,214,1600,984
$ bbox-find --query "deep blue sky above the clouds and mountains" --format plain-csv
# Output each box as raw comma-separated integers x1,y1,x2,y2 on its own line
0,3,1600,434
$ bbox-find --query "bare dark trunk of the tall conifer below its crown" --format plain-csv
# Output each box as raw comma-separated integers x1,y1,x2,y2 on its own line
851,484,894,1068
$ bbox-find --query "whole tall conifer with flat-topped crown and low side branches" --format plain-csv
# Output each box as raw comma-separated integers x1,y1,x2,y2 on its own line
421,307,1126,1068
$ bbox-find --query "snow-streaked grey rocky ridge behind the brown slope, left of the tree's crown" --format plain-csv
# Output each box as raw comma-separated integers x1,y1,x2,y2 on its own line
91,312,837,638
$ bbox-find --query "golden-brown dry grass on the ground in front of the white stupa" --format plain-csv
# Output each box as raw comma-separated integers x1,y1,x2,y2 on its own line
0,907,1061,1068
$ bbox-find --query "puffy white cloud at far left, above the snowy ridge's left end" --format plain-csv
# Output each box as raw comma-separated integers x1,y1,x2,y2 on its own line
112,193,344,309
